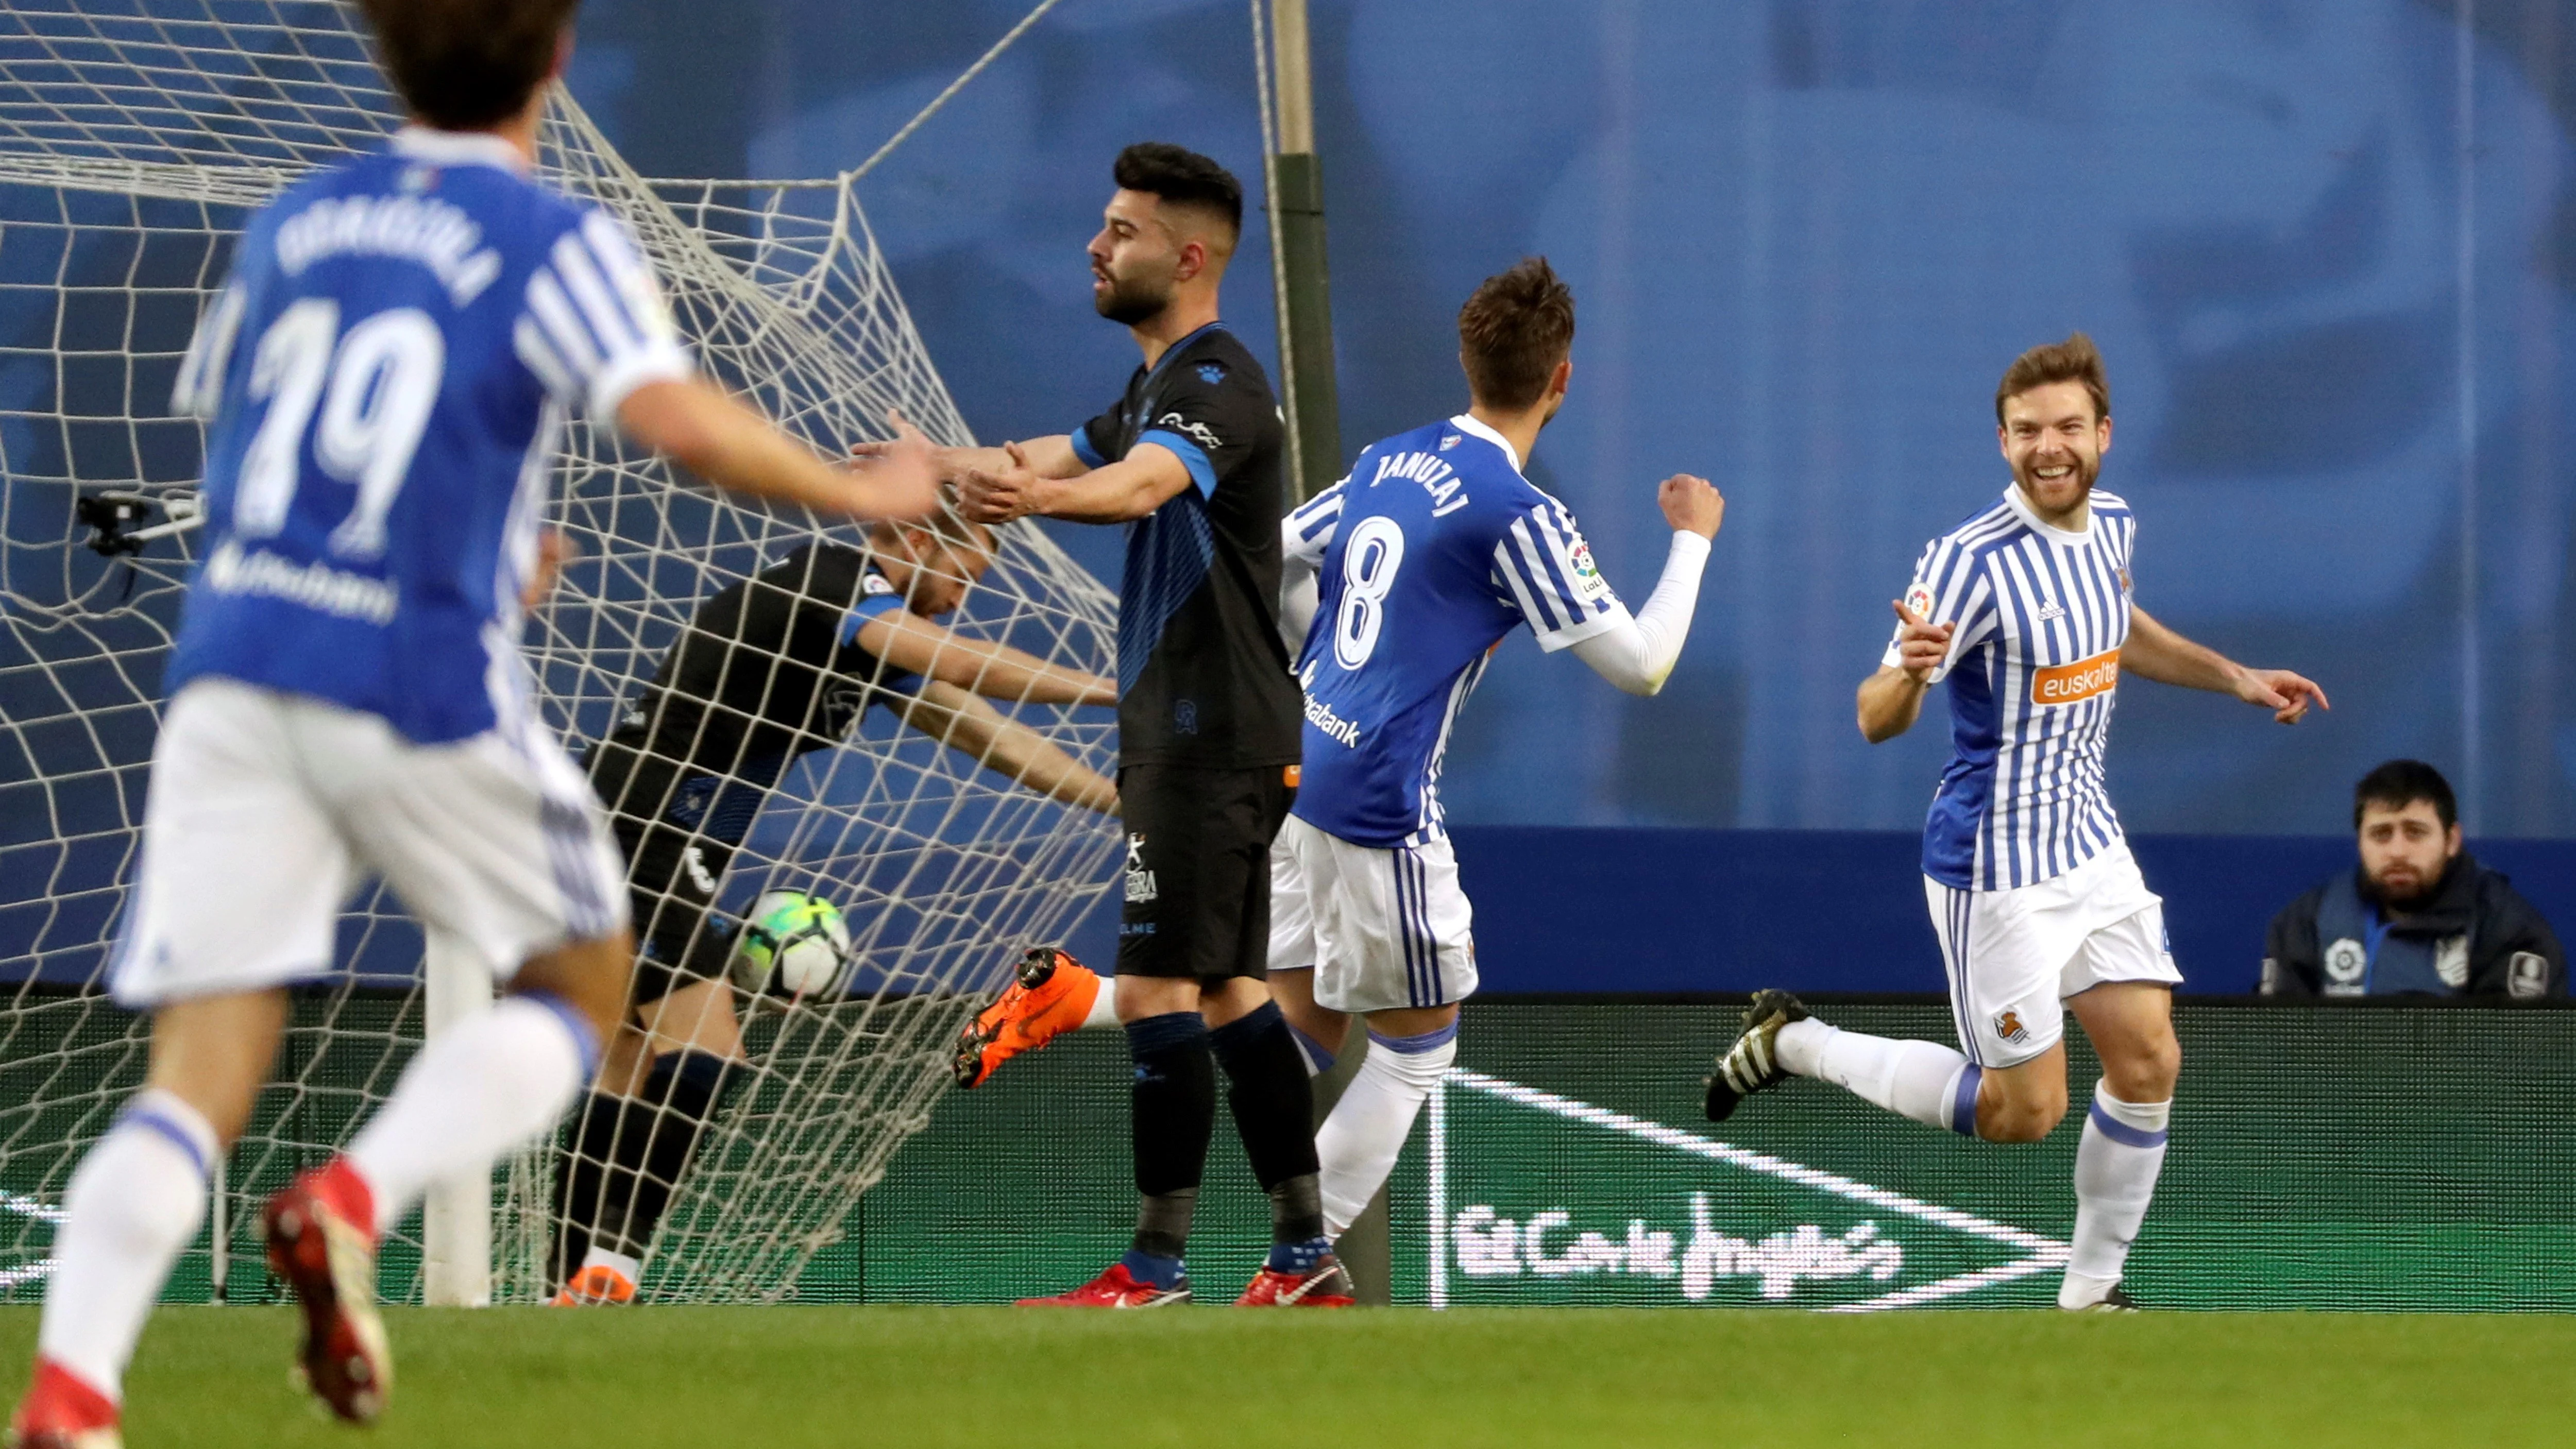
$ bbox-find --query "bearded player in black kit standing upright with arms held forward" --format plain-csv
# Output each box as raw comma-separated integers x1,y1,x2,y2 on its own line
943,144,1350,1307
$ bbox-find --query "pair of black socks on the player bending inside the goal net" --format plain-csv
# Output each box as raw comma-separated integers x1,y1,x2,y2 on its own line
554,1053,739,1282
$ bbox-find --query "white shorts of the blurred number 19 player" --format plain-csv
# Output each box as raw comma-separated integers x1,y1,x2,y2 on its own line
111,679,626,1007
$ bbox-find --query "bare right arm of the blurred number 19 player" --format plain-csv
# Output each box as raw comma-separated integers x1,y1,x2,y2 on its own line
618,378,940,520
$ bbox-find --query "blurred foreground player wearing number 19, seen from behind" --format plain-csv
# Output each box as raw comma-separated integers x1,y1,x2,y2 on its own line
10,0,938,1449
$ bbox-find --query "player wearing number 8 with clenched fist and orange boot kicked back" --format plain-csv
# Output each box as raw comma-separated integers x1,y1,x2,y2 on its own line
958,258,1726,1302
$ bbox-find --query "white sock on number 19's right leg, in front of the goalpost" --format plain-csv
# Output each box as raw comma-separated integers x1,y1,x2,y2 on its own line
348,991,598,1233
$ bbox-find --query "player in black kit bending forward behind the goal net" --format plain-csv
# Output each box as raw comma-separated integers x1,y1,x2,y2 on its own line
549,512,1118,1305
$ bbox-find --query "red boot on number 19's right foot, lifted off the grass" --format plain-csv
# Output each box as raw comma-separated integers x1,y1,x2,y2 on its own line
265,1158,394,1423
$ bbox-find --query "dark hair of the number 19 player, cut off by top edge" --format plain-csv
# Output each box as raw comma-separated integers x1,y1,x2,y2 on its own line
358,0,582,131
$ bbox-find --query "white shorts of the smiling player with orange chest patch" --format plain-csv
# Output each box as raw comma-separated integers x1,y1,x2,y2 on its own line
1924,842,2182,1066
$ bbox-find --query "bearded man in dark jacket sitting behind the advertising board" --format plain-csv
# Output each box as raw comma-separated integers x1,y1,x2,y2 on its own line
2262,759,2568,999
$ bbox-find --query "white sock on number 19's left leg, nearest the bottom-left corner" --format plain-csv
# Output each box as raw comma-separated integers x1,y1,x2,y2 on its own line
36,1088,216,1400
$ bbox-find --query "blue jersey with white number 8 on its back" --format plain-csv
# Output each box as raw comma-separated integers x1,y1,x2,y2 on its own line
1285,417,1628,849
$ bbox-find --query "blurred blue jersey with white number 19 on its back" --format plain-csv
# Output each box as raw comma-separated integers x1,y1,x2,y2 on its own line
167,126,690,744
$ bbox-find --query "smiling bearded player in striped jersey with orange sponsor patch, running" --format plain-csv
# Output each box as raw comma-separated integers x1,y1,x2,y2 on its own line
1708,332,2326,1310
